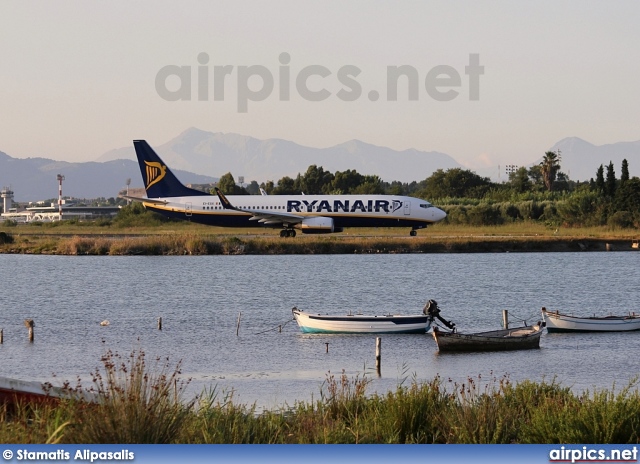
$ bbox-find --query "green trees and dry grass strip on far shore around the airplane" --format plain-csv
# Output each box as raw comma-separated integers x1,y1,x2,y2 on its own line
0,156,640,255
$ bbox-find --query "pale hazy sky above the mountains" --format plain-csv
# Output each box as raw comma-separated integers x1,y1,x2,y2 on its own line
0,0,640,170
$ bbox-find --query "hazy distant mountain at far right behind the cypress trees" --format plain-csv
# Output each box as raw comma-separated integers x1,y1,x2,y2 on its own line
537,137,640,181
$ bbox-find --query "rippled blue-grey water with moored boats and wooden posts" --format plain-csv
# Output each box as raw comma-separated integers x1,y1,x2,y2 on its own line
0,252,640,407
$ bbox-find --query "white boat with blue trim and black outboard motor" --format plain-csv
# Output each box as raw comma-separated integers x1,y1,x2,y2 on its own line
291,300,448,334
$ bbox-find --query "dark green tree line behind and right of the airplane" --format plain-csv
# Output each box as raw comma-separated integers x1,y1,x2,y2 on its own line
212,150,640,228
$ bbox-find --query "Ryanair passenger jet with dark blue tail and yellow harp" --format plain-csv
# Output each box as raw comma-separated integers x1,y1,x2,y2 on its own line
122,140,447,237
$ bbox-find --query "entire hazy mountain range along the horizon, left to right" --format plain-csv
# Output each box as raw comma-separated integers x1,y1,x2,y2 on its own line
0,128,640,202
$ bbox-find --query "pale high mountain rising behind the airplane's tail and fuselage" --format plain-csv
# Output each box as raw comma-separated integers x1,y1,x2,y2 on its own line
97,128,461,186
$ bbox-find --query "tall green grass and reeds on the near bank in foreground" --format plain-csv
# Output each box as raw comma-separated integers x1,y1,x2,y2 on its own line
0,351,640,444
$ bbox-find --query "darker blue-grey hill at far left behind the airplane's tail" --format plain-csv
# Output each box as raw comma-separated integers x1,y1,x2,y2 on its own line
0,152,217,202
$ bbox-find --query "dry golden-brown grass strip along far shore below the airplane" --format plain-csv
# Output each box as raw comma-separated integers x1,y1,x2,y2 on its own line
0,220,640,256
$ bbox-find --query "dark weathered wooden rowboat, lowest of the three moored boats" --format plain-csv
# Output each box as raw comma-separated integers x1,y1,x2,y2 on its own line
433,322,543,352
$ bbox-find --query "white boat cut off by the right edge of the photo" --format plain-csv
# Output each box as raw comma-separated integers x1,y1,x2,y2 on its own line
542,308,640,332
